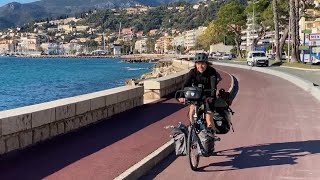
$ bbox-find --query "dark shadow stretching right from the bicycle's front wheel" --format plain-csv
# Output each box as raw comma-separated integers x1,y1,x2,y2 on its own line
199,140,320,172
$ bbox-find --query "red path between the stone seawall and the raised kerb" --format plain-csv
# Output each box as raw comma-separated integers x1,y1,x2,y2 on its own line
0,72,231,180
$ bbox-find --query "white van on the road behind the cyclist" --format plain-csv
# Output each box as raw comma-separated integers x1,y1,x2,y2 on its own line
247,51,269,66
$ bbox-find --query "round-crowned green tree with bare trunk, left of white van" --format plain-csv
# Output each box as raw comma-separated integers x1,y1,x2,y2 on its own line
217,2,247,58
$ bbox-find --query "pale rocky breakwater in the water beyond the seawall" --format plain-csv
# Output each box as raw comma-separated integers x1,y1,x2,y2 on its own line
125,61,183,85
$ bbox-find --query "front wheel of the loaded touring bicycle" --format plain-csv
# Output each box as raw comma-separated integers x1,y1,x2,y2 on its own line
187,125,200,171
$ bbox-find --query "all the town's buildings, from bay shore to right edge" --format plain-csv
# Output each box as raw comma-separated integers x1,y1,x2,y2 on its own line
0,0,320,64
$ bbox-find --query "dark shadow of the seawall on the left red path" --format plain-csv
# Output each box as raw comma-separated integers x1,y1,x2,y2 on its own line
0,100,184,179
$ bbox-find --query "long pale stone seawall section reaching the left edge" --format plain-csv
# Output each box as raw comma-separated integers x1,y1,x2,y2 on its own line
0,86,144,154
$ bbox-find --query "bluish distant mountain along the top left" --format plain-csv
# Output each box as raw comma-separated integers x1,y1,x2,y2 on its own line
0,0,198,29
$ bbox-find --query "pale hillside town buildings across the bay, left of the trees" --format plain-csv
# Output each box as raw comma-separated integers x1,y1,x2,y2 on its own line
0,2,212,56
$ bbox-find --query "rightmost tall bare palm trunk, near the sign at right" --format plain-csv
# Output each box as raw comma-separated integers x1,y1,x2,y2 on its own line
289,0,298,63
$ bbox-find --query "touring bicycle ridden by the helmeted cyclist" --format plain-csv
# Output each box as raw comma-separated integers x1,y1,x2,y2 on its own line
175,81,234,171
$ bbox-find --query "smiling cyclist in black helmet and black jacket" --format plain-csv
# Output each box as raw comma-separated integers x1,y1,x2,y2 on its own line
178,53,221,130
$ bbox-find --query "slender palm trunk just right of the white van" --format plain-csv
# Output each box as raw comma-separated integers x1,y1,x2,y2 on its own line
272,0,281,62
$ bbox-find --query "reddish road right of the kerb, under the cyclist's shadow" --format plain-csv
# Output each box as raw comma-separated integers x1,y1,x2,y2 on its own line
141,67,320,180
